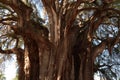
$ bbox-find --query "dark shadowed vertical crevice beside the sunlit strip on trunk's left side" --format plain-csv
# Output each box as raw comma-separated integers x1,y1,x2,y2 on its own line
25,38,40,80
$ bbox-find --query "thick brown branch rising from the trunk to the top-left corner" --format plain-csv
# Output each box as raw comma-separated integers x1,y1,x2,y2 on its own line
0,0,32,27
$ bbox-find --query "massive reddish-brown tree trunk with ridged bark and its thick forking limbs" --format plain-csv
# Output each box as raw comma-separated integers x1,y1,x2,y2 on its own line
0,0,118,80
